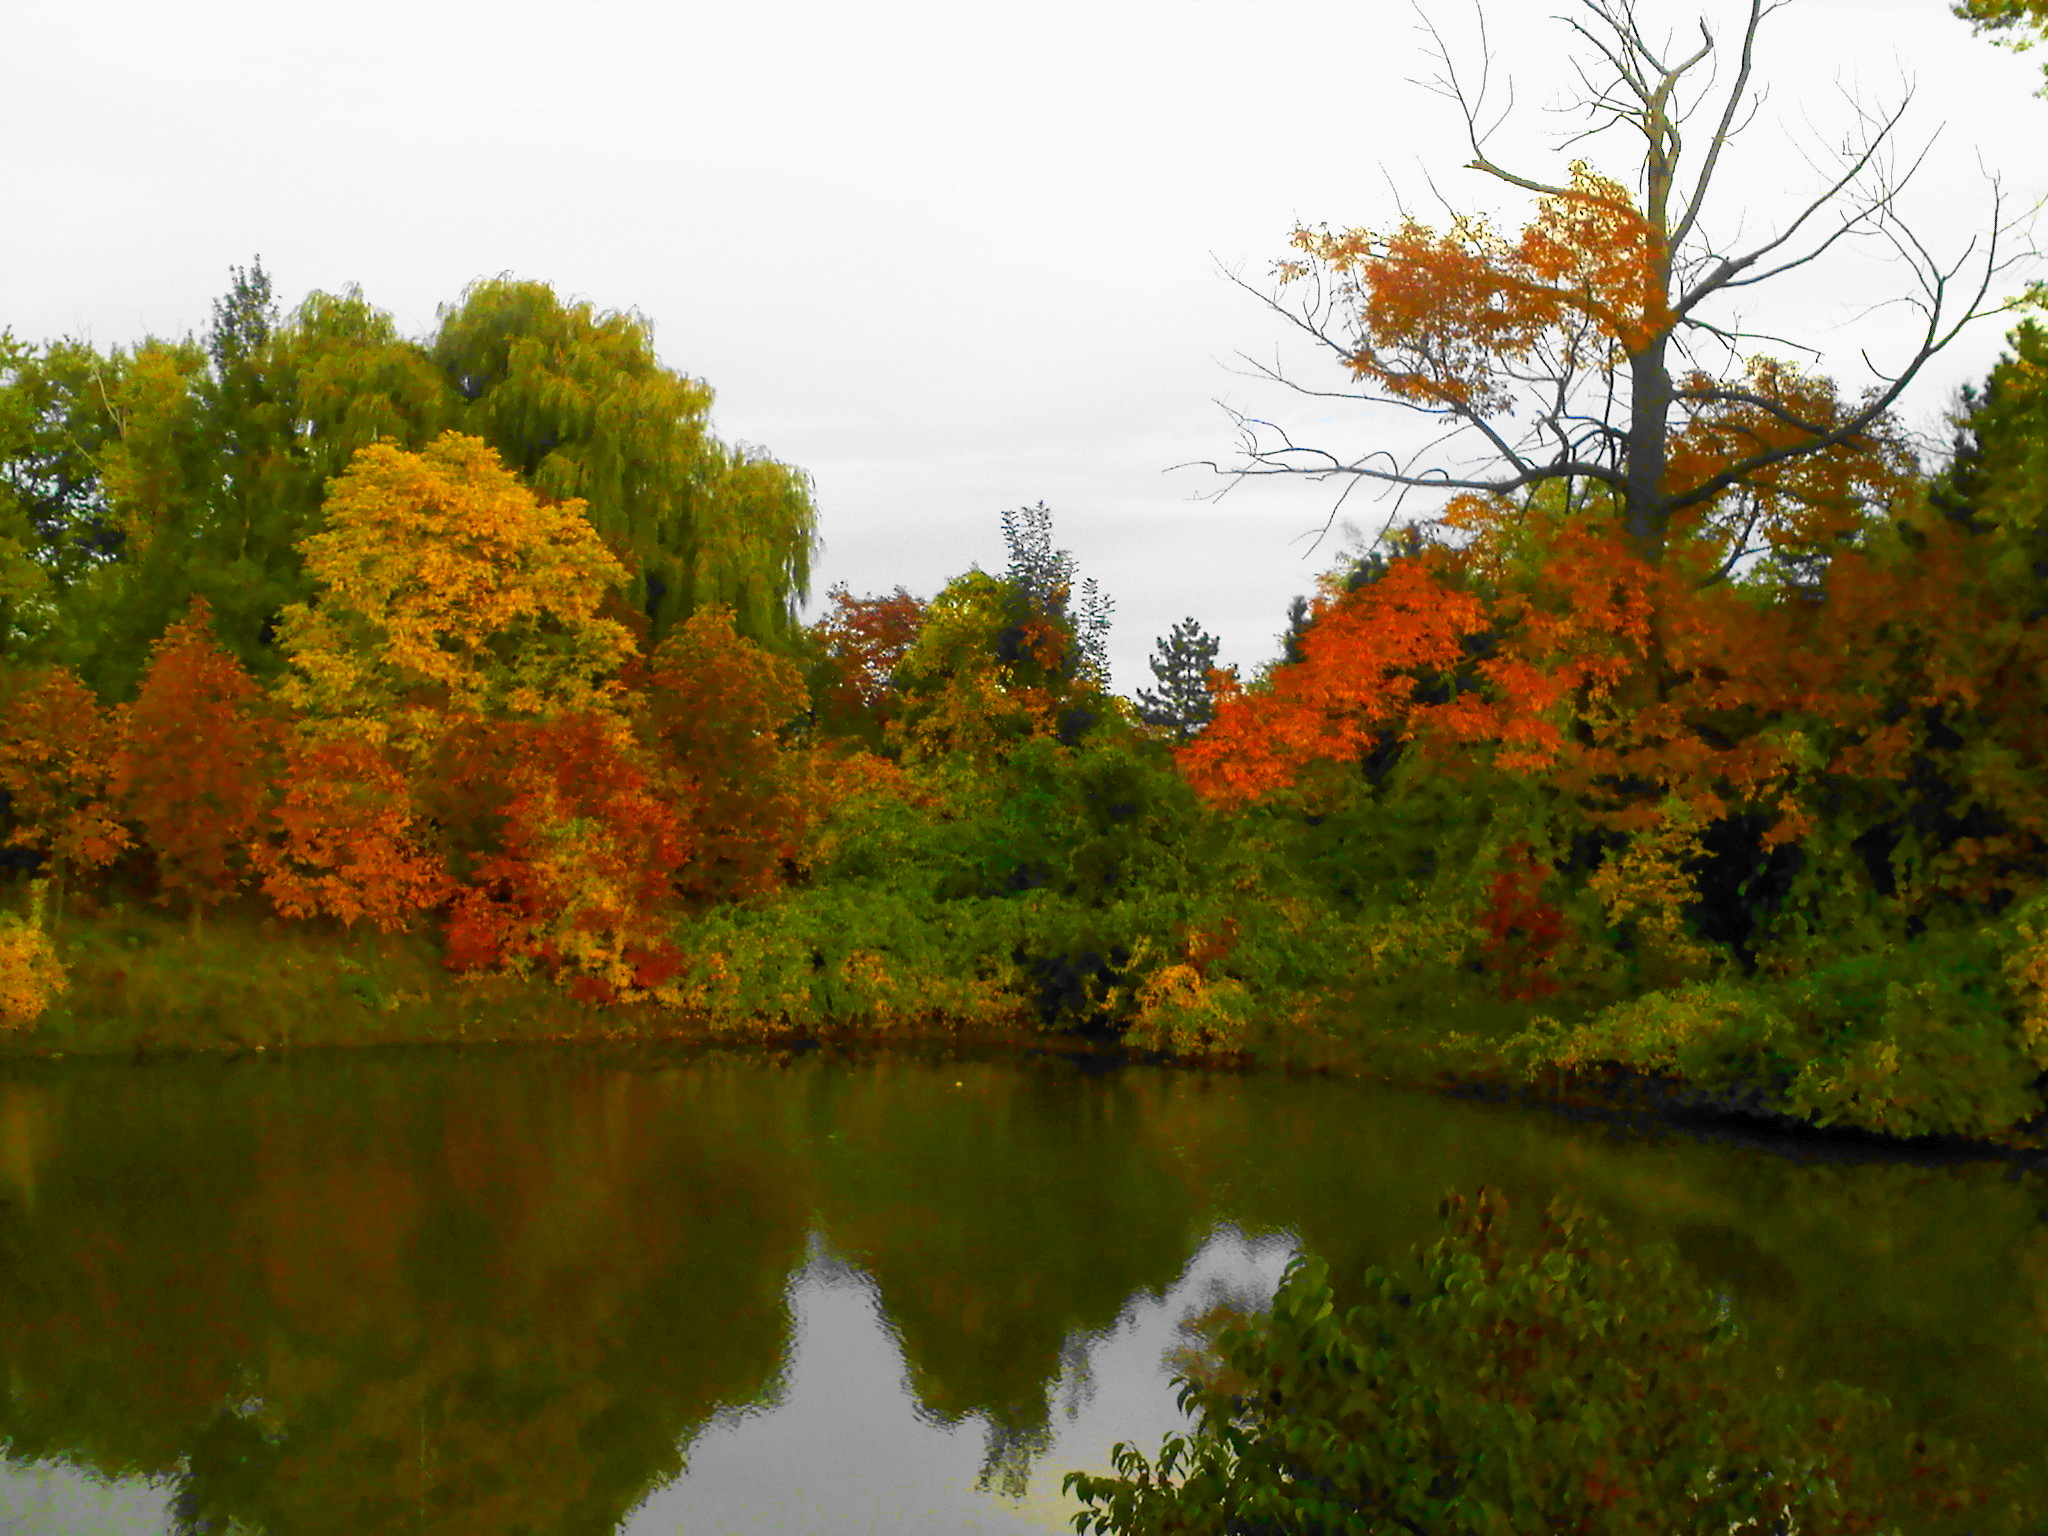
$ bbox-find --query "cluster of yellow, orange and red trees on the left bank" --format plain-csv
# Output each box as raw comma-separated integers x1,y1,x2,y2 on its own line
121,434,809,1001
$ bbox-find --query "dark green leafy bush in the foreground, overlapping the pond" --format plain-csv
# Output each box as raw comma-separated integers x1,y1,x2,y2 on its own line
1065,1188,2023,1536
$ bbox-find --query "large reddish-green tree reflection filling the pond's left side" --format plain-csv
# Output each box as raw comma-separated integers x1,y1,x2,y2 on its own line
0,1061,807,1532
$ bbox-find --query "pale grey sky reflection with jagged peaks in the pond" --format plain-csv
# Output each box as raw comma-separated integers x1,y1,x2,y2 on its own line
0,1225,1294,1536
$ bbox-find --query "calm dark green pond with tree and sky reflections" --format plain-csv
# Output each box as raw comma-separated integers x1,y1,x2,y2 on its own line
0,1049,2048,1536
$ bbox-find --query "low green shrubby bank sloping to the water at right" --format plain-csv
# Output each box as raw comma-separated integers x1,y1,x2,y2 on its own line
1268,907,2048,1151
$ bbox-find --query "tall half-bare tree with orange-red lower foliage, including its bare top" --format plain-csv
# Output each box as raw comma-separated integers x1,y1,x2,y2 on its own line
1184,0,2013,974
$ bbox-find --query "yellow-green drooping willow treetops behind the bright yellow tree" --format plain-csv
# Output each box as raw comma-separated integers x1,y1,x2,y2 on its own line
0,264,817,696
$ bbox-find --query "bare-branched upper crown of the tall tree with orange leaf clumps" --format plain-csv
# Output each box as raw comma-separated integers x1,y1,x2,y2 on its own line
1202,0,2034,575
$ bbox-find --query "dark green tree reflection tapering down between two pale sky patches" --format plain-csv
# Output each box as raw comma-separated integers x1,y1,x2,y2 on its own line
817,1063,1202,1493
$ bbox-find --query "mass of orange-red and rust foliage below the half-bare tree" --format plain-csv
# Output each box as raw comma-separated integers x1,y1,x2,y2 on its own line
1180,284,2048,1028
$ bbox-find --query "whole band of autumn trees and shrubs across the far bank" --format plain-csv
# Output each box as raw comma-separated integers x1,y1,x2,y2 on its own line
0,225,2048,1179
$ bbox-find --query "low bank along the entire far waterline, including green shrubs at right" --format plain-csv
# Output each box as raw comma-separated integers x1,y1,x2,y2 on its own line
16,899,2048,1149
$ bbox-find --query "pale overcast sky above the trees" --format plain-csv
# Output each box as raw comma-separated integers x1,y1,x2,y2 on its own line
0,0,2048,692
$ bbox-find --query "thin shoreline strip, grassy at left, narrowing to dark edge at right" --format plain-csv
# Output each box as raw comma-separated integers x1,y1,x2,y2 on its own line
0,907,2048,1167
